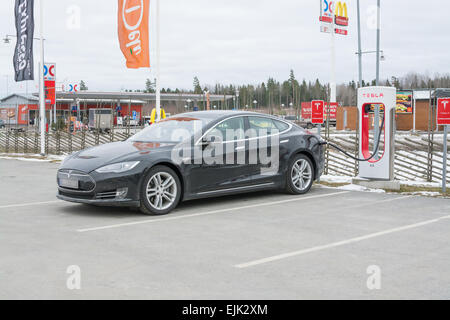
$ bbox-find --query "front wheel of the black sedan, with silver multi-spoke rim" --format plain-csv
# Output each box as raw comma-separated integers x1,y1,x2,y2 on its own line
141,166,181,215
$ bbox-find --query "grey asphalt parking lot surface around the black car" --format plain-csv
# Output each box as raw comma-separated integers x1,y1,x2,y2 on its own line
0,160,450,299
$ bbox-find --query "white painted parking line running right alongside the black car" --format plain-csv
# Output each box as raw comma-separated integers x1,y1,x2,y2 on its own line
77,191,350,232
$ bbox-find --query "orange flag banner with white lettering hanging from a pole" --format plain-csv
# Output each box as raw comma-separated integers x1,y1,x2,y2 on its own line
118,0,150,69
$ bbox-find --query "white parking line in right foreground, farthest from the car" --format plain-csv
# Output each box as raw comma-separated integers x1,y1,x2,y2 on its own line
235,215,450,269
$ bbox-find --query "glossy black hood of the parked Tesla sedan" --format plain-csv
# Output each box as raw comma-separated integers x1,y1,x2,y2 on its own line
60,141,175,173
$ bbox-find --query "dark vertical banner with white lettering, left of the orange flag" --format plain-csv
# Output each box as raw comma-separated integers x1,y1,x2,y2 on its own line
13,0,34,82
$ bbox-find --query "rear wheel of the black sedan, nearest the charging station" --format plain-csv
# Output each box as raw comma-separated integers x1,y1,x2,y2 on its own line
286,154,314,194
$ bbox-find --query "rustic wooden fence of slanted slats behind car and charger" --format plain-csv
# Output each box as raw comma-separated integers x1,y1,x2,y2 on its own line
0,131,450,182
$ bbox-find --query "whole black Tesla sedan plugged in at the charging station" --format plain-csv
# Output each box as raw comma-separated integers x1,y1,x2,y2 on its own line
57,111,324,215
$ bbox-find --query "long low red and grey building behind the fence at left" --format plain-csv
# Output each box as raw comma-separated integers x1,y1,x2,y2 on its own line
0,91,233,126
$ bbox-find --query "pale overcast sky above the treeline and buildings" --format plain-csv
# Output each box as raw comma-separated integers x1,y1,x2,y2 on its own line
0,0,450,96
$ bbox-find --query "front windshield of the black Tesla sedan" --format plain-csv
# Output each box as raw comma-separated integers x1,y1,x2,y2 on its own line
128,117,208,143
